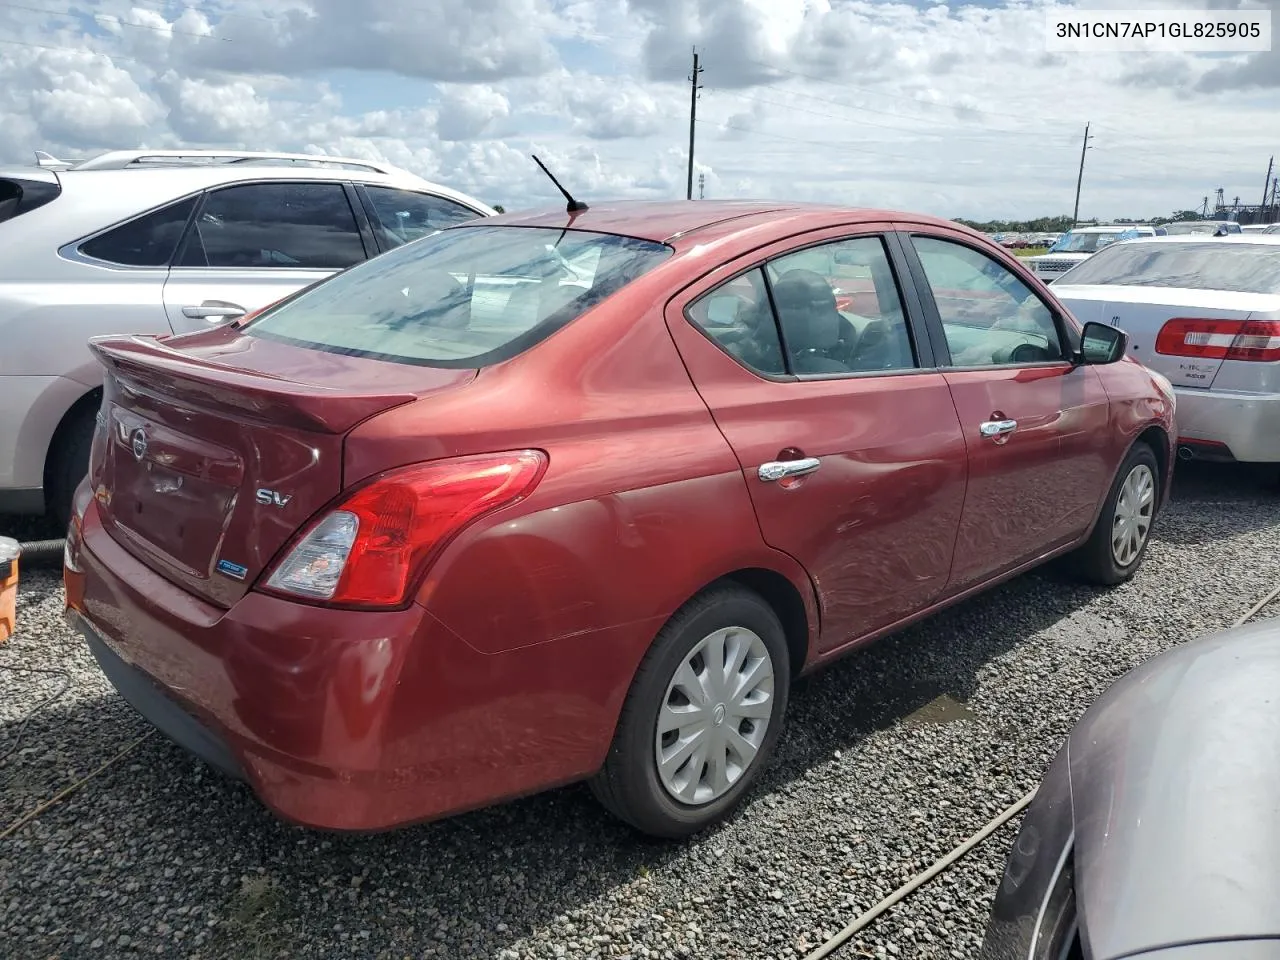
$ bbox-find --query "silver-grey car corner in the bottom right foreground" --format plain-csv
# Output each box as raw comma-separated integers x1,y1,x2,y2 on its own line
979,620,1280,960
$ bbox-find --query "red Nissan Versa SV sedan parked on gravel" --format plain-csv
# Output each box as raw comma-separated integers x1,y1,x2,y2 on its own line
65,201,1176,837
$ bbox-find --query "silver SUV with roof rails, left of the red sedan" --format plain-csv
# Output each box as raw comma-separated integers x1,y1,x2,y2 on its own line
0,151,497,524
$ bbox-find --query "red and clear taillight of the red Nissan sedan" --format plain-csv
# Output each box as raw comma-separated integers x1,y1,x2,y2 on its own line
264,451,547,607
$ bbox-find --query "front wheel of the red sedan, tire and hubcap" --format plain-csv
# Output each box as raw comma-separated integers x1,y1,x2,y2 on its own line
1073,443,1160,586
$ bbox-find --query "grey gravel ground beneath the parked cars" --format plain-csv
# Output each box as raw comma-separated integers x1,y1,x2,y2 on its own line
0,467,1280,960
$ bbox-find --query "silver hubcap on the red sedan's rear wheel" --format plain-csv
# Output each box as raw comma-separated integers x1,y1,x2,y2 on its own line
654,627,773,804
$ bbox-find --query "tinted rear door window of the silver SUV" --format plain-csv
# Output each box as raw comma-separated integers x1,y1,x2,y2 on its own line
178,182,365,270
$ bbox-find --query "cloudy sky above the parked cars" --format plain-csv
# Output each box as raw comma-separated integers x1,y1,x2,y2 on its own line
0,0,1280,218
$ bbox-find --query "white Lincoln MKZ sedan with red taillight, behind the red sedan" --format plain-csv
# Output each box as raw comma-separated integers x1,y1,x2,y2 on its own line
1053,234,1280,463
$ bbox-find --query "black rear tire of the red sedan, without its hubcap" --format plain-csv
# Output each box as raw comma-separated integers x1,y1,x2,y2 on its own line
590,586,791,840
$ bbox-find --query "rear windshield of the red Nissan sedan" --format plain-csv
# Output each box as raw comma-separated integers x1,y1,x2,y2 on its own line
246,227,672,367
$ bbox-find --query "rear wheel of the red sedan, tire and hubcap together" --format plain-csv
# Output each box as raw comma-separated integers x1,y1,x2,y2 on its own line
591,586,791,838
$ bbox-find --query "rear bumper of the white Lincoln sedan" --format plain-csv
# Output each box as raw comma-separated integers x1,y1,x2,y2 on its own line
1174,388,1280,463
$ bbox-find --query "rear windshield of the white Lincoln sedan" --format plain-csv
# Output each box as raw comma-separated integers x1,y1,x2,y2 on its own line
1057,239,1280,293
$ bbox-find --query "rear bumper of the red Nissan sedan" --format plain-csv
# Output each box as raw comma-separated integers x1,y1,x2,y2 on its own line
64,504,637,831
